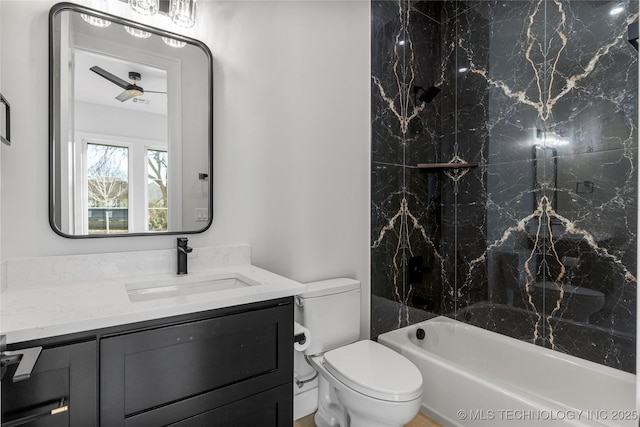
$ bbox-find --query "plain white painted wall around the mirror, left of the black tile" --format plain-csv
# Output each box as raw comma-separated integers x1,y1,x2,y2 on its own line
0,0,370,335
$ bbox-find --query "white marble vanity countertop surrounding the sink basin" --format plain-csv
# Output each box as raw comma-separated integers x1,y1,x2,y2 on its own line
0,247,306,344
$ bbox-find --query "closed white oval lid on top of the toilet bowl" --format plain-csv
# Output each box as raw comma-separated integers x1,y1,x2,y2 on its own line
324,340,422,402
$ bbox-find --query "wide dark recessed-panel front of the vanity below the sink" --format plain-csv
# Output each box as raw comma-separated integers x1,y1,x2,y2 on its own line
100,304,293,427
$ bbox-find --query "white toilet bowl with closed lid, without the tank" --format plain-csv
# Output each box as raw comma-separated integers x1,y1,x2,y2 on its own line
311,340,422,427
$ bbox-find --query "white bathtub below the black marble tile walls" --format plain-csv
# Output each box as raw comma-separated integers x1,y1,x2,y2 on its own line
378,316,638,427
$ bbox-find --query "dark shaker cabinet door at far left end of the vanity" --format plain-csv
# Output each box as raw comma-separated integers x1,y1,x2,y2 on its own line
2,340,98,427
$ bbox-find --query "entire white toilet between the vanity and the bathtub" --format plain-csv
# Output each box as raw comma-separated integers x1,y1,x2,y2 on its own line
295,279,422,427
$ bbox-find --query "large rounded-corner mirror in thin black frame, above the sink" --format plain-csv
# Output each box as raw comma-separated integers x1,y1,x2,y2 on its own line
49,3,213,238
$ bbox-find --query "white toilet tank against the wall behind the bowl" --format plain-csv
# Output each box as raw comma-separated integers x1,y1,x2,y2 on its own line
295,279,360,355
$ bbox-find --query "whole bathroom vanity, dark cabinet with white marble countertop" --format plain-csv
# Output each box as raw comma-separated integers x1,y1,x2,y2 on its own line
0,247,306,427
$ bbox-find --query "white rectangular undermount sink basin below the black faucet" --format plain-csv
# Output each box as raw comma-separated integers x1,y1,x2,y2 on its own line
125,273,260,302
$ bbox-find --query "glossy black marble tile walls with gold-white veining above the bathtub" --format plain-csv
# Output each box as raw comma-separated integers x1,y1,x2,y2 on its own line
371,0,638,372
